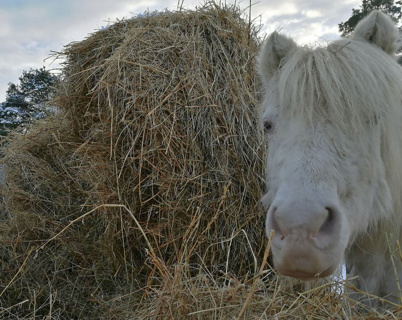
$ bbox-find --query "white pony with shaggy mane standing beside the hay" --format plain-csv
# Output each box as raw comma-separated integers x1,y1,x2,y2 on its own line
258,12,402,303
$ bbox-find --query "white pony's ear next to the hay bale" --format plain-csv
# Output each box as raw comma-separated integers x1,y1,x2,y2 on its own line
257,31,297,83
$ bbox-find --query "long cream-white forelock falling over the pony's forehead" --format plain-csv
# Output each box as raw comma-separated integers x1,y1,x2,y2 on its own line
277,39,402,131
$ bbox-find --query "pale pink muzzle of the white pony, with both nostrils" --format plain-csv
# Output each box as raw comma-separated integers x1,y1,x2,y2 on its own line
267,201,341,279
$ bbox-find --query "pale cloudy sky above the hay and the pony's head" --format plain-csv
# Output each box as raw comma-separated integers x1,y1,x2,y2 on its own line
0,0,362,102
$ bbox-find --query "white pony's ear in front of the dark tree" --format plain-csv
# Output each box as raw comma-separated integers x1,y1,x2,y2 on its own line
351,10,399,55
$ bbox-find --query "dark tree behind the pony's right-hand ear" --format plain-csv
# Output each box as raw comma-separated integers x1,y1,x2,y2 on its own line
339,0,402,37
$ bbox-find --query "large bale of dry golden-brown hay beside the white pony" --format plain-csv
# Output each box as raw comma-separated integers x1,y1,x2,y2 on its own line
0,4,264,319
